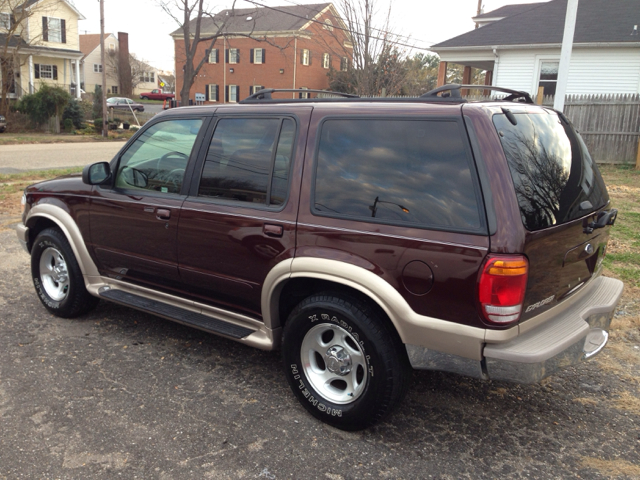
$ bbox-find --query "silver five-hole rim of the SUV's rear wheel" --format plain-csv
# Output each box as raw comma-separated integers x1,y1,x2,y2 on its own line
300,323,368,404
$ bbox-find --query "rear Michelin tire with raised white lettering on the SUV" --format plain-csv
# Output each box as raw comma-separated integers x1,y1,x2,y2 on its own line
282,293,411,430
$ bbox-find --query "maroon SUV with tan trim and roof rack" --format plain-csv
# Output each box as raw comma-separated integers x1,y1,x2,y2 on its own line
18,85,623,430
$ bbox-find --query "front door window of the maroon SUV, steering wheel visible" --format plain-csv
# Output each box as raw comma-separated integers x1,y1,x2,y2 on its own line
115,119,202,194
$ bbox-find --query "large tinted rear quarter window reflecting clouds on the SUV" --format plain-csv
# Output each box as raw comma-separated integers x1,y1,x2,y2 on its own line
314,119,482,230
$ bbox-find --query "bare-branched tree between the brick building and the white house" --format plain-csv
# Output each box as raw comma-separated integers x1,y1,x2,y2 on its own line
327,0,408,96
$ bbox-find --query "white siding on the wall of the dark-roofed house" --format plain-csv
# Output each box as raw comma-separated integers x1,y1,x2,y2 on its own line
493,48,640,95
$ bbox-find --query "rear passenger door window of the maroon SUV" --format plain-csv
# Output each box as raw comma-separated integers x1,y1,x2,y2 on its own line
198,118,295,205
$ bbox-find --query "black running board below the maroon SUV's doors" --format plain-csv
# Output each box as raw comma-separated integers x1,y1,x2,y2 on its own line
99,289,254,340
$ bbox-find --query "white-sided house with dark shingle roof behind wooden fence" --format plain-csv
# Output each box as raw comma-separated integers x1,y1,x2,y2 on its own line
431,0,640,95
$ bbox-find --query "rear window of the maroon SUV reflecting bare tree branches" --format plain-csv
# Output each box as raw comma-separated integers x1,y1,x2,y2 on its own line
493,110,609,231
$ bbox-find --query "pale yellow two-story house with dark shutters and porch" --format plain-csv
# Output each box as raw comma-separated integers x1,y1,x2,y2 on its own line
0,0,85,98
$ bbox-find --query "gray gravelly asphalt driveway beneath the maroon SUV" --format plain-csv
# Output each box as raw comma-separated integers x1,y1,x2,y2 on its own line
0,229,640,480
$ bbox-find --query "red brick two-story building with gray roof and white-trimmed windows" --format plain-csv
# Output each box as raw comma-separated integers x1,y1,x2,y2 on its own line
171,3,352,103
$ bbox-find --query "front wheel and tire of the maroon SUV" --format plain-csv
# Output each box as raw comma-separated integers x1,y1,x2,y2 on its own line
31,228,99,318
